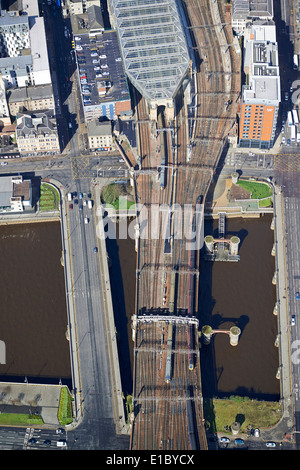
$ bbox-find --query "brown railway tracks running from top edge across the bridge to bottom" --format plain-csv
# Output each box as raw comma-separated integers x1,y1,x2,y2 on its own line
130,0,239,450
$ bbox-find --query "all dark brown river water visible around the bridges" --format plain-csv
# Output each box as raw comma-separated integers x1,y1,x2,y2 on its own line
0,215,279,400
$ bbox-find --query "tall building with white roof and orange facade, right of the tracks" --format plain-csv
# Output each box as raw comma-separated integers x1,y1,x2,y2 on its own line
239,23,281,149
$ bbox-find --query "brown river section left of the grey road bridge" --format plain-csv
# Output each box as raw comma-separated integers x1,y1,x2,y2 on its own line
0,222,71,384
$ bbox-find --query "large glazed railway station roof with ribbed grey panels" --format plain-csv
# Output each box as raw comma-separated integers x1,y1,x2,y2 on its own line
110,0,189,100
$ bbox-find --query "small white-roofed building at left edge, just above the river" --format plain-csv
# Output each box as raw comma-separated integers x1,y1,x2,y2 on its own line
0,176,32,214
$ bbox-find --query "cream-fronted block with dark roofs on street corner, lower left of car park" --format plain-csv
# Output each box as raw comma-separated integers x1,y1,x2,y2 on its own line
16,109,60,156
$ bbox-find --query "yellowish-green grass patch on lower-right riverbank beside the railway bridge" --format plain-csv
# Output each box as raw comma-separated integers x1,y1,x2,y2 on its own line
204,396,282,433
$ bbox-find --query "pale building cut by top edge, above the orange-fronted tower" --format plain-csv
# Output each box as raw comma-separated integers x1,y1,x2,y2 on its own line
231,0,274,35
